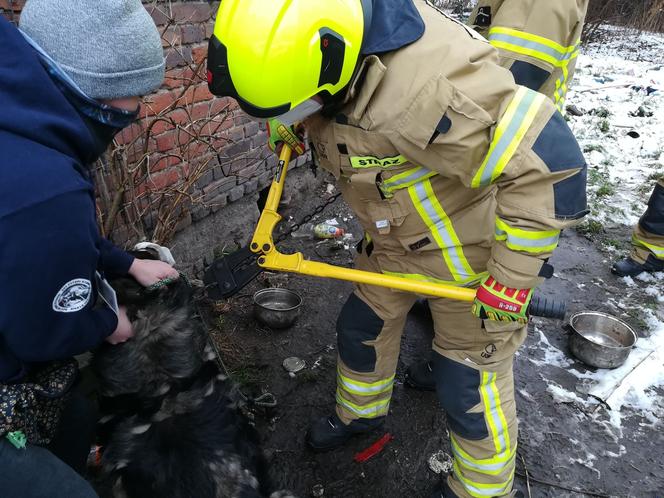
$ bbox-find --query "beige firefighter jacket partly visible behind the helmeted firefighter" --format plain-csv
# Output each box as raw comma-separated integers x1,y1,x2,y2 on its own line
469,0,589,111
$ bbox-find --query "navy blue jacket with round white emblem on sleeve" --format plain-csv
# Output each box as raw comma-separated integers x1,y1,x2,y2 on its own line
0,16,133,382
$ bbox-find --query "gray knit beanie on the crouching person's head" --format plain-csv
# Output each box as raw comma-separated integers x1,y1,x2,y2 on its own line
20,0,164,99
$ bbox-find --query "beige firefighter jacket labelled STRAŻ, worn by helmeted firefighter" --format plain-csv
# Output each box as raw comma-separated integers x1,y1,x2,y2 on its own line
305,0,586,288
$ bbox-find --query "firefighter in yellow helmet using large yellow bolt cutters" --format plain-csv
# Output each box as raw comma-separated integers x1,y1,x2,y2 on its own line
208,0,587,498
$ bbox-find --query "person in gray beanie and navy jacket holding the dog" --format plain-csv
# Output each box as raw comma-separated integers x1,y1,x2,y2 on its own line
0,0,178,498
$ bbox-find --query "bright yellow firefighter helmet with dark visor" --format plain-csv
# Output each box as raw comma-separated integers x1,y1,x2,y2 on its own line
208,0,372,118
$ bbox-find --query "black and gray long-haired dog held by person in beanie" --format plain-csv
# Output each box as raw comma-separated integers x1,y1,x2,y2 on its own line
93,260,291,498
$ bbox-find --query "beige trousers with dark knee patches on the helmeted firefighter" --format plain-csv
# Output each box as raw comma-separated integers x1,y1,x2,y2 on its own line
336,254,526,498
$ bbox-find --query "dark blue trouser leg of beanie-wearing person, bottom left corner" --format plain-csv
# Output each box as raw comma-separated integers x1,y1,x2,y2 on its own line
0,438,97,498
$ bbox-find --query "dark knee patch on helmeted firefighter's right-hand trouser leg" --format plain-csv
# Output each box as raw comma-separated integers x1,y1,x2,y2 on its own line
433,353,489,441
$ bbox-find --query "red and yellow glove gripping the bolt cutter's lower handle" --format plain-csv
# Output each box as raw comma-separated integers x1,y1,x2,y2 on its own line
472,275,533,325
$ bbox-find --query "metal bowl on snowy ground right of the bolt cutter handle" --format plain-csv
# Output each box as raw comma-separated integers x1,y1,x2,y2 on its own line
569,311,638,368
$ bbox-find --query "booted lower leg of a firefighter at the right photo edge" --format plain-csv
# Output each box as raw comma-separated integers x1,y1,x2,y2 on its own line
611,178,664,277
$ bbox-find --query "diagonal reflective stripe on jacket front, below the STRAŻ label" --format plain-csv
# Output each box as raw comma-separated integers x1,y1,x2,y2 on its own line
408,179,477,282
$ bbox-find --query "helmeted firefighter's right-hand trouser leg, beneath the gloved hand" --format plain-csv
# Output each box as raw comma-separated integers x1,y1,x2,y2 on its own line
430,299,526,498
